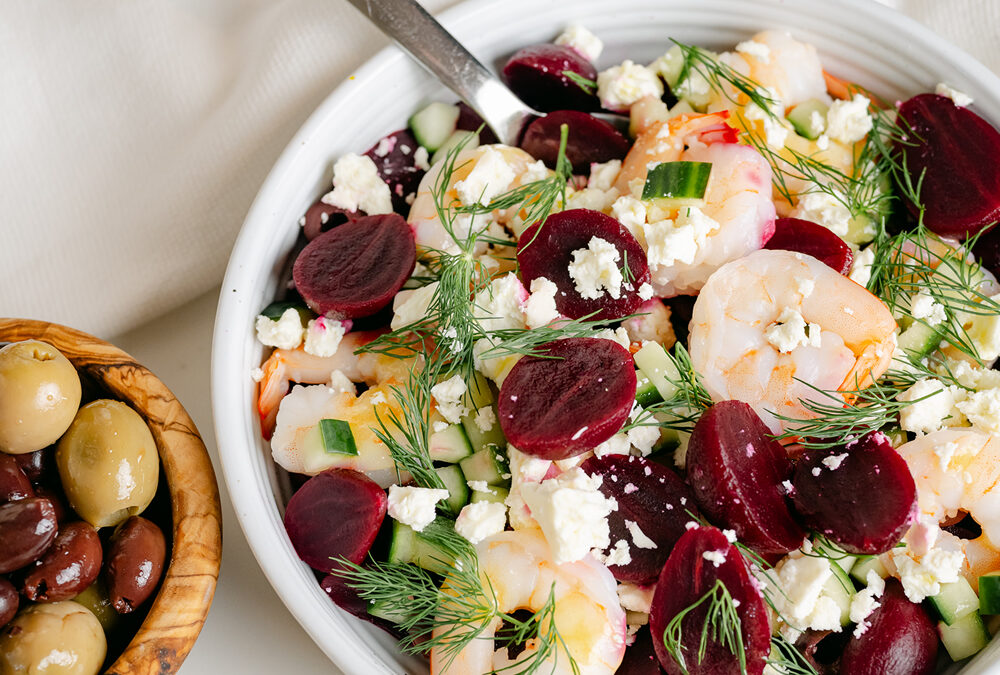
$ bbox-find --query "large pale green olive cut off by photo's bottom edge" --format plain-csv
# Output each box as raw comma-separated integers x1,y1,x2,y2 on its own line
0,601,108,675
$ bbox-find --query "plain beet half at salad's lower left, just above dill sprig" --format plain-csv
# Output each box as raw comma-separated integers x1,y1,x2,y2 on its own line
285,469,387,572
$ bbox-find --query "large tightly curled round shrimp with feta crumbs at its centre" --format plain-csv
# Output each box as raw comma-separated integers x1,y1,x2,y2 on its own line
689,250,896,432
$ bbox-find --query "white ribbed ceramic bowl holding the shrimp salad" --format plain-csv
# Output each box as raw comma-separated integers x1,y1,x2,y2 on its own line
212,0,1000,675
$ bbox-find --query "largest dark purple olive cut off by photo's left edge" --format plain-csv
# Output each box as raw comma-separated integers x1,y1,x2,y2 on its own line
0,497,58,574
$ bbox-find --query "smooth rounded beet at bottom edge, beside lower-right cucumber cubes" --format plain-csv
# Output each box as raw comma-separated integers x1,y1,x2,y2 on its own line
840,578,938,675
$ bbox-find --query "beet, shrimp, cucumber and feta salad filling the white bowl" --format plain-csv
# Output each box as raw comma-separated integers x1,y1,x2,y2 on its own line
246,26,1000,675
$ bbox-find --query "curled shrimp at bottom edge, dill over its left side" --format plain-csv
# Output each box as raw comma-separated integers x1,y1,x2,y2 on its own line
431,529,626,675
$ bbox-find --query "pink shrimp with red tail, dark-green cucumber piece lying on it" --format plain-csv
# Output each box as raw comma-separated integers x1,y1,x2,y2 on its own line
615,112,775,297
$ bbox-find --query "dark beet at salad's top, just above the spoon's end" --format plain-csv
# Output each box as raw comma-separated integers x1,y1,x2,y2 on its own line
501,44,601,112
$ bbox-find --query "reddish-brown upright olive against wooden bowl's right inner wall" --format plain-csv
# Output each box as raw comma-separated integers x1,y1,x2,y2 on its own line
106,516,167,614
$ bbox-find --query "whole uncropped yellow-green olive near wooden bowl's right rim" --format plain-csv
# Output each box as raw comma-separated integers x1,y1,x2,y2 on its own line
56,399,160,528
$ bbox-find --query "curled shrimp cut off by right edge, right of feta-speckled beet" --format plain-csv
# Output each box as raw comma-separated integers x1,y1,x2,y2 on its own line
898,429,1000,588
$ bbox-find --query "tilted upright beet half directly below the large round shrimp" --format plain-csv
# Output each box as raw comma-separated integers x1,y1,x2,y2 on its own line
687,401,806,556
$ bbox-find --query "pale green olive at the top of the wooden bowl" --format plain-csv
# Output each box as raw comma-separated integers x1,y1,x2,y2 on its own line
0,340,80,455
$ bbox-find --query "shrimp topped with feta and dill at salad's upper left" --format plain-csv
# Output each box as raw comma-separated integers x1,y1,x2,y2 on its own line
407,145,552,254
